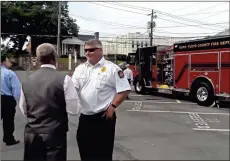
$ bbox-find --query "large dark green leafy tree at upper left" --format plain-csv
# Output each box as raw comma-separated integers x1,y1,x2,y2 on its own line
1,1,79,53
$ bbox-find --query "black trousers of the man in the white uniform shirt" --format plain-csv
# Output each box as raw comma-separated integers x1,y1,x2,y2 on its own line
77,112,116,161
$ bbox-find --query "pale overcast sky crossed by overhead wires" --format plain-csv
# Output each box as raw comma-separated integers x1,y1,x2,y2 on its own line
69,2,229,37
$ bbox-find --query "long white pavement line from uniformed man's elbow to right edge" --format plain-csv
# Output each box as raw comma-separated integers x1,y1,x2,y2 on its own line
126,110,229,116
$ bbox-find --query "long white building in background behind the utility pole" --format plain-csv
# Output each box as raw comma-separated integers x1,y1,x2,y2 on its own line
100,32,206,55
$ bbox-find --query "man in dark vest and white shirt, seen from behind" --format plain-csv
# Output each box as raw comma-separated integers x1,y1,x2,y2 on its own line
19,43,79,161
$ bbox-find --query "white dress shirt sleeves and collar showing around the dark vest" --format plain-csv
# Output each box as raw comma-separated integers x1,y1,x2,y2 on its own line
19,64,80,116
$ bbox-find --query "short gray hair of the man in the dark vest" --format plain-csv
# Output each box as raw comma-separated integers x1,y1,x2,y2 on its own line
36,43,57,64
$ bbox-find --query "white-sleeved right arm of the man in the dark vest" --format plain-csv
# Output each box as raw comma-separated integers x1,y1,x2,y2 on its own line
64,75,80,115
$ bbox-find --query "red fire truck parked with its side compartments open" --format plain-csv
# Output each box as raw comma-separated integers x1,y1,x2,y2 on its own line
127,36,230,106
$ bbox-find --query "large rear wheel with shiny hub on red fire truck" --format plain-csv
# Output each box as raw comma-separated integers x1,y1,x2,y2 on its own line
196,82,215,106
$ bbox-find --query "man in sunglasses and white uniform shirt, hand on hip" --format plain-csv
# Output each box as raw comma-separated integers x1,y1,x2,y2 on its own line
72,39,131,161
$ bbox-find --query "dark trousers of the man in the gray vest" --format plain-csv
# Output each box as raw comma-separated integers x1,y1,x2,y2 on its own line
24,133,67,161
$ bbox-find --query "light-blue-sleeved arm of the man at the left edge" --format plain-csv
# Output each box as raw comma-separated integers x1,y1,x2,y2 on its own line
10,71,21,102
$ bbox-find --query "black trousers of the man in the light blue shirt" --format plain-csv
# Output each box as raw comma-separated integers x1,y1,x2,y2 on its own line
1,95,17,143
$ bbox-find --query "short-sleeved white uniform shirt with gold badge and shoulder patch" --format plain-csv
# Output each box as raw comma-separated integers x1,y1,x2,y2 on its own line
72,57,131,115
